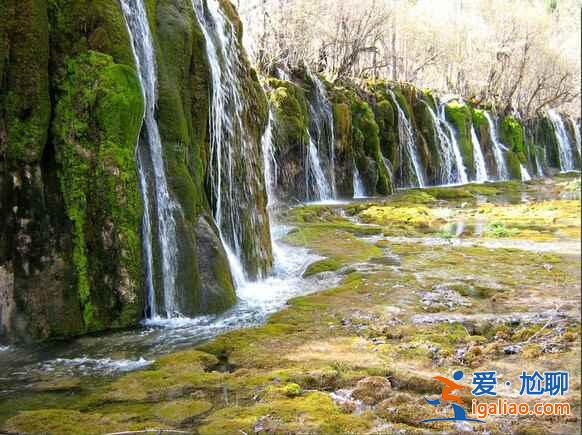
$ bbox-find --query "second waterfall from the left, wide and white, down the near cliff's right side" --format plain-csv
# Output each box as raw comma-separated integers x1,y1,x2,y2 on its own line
192,0,270,287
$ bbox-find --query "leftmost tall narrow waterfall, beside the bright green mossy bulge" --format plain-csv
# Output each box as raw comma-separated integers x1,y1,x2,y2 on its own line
121,0,181,317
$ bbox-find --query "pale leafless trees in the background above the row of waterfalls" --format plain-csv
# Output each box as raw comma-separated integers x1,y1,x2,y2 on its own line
241,0,582,117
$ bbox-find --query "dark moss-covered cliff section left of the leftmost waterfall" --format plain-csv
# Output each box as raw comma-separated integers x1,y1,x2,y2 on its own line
0,0,144,339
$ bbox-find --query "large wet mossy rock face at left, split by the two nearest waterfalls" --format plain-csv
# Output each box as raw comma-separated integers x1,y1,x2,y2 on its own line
0,0,270,340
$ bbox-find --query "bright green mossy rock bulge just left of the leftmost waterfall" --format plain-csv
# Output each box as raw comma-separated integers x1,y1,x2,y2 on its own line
54,52,143,331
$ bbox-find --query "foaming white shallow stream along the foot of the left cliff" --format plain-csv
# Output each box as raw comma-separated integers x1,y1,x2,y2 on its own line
0,226,339,395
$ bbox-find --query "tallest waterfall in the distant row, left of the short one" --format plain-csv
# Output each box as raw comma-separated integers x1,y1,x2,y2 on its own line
307,69,336,198
